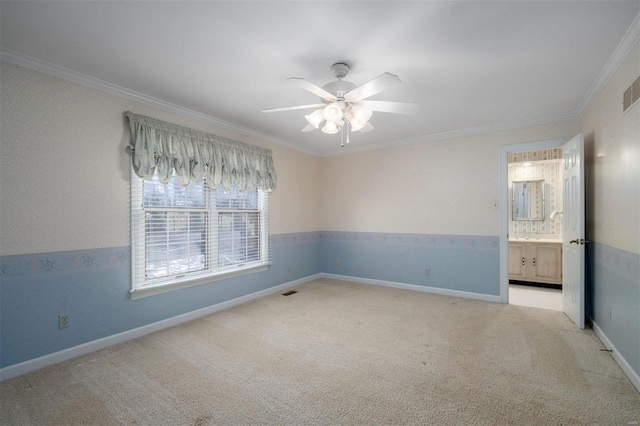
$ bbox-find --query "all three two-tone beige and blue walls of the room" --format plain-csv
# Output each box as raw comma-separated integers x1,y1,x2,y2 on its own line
0,47,640,380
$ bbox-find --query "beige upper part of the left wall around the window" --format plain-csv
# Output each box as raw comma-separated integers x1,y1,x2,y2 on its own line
0,62,320,255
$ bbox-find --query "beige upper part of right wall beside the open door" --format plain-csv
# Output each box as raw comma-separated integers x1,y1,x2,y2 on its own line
582,42,640,254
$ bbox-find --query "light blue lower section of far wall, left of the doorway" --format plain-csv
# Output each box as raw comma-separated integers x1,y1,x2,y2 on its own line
320,232,500,296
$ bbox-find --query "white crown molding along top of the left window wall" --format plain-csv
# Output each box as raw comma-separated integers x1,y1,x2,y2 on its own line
0,49,319,156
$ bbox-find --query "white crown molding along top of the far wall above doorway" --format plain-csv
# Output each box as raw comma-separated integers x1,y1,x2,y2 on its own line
320,112,580,157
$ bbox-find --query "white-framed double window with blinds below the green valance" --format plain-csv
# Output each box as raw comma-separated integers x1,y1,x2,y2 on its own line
131,174,270,298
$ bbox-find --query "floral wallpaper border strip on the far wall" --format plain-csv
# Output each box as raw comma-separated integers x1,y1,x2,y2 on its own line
320,231,500,250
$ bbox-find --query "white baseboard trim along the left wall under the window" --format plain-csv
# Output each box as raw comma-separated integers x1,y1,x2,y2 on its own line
0,274,321,381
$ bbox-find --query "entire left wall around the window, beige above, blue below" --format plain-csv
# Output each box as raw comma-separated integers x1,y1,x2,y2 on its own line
0,62,320,367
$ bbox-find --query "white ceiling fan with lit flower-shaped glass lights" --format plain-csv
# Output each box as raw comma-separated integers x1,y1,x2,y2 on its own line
262,62,418,146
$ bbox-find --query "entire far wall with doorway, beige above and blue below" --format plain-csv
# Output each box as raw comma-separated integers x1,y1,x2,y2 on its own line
321,122,580,298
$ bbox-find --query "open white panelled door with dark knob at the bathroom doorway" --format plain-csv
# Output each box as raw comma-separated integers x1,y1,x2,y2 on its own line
562,134,586,328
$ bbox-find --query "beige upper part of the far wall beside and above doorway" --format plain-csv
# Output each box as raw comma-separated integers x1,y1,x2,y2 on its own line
321,121,580,235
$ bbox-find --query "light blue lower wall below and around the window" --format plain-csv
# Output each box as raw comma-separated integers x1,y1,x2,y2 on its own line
0,232,320,368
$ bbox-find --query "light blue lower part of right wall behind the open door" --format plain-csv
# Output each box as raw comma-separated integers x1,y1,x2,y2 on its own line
586,242,640,375
